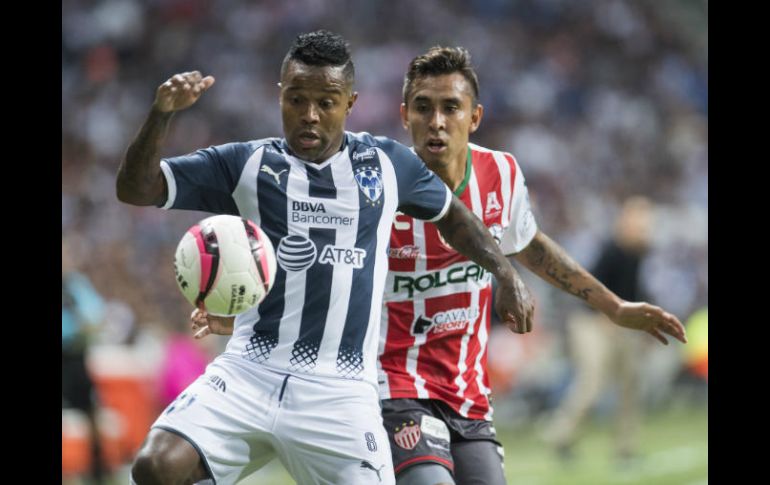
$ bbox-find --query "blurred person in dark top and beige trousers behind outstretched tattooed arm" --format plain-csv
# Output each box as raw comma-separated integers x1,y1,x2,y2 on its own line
546,197,652,462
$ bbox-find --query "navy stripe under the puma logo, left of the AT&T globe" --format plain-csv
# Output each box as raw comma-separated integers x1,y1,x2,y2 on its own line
244,146,289,362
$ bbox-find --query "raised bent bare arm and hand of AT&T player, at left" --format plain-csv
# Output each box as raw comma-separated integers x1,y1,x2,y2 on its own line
117,71,214,205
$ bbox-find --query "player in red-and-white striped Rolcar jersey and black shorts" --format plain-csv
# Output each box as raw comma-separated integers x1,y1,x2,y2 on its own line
379,47,686,485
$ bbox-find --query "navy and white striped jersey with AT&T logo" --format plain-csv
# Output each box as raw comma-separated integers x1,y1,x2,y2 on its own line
161,132,452,386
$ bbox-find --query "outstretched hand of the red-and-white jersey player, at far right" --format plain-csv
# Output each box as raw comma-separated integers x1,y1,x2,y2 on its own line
607,301,687,345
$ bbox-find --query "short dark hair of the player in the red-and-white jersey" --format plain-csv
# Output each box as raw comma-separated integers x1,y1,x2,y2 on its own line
403,46,479,107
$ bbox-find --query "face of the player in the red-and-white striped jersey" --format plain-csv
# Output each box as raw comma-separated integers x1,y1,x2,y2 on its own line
401,73,483,173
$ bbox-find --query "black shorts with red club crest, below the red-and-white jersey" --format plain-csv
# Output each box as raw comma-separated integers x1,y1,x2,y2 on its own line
382,399,502,476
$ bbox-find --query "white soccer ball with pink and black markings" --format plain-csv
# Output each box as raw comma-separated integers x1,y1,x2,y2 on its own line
174,215,276,316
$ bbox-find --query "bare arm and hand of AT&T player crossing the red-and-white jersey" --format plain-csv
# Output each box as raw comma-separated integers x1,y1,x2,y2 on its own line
435,196,535,333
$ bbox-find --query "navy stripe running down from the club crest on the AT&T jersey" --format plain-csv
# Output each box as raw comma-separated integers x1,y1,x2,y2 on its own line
337,144,385,378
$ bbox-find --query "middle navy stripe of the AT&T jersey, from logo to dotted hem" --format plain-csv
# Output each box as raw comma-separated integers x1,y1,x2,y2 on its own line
289,226,337,372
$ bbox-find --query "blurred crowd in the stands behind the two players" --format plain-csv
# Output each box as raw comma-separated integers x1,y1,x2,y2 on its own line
62,0,708,476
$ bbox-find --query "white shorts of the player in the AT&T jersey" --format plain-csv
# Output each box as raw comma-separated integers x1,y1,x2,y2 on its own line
152,355,395,485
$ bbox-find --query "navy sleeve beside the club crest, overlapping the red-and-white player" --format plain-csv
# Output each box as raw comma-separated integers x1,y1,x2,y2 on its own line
378,137,452,222
